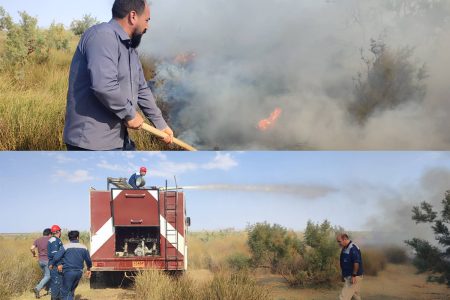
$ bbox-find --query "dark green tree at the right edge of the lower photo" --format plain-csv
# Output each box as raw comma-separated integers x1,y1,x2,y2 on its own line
405,191,450,286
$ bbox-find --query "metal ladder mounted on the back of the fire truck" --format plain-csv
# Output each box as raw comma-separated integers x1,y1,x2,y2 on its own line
163,183,180,271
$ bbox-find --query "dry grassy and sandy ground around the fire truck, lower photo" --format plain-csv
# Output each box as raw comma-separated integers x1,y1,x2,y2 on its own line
0,230,450,300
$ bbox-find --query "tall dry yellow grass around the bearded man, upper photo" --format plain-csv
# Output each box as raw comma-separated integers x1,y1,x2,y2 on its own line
0,36,178,150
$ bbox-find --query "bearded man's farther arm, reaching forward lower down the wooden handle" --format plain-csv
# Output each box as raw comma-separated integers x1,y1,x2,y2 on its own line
138,61,173,143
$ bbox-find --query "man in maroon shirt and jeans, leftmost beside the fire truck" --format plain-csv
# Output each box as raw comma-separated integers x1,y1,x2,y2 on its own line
30,228,51,299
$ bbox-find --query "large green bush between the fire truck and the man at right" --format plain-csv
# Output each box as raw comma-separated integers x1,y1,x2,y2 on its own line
248,221,339,287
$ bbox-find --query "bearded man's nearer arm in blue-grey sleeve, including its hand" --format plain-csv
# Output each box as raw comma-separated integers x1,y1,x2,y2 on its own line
84,31,136,121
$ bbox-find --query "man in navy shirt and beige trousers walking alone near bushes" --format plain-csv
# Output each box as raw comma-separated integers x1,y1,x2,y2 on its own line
336,233,364,300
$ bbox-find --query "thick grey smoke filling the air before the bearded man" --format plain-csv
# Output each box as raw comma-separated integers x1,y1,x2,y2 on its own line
141,0,450,150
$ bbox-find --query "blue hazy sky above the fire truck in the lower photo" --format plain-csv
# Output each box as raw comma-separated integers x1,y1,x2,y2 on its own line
0,151,450,245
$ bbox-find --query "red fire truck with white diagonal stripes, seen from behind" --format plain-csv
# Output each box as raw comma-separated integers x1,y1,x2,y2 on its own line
90,178,190,288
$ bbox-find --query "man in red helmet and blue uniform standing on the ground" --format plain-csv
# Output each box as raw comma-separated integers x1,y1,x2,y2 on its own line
47,225,63,300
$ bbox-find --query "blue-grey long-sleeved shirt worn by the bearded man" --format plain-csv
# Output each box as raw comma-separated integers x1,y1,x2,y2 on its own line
64,19,167,150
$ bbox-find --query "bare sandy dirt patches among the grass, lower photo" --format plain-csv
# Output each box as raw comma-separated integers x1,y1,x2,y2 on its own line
18,265,450,300
